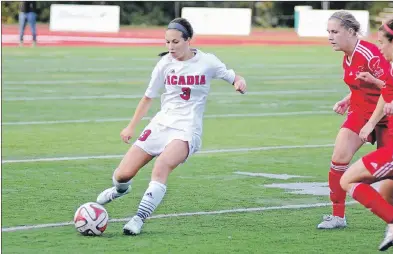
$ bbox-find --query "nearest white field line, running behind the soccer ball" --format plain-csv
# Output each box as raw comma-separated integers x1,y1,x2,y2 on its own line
1,201,357,232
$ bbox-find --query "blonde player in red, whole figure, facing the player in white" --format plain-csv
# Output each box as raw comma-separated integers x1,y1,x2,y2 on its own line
318,11,390,229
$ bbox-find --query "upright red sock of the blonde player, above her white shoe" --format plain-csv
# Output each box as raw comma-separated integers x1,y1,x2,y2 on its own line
329,161,348,218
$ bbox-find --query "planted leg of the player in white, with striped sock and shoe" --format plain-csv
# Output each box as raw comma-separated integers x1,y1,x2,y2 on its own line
123,139,189,235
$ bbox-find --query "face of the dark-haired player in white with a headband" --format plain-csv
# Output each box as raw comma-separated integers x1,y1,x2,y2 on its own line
165,29,190,60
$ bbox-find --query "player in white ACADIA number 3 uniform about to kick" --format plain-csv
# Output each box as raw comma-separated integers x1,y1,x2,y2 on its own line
97,18,246,235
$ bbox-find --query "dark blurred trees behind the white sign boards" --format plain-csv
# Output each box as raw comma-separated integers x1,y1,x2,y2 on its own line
1,1,388,27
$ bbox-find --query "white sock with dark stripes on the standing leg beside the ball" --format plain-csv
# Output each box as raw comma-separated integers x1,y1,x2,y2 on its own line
136,181,166,220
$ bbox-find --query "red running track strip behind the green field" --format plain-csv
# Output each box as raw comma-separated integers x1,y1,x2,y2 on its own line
2,24,327,46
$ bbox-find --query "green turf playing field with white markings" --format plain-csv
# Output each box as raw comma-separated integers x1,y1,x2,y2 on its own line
2,46,385,254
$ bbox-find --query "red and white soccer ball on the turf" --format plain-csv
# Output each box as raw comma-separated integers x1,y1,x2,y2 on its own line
74,202,108,236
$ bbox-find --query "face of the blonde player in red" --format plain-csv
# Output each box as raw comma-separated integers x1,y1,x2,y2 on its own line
327,18,352,51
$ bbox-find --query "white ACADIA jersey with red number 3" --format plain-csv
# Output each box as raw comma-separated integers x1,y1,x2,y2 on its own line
145,49,235,138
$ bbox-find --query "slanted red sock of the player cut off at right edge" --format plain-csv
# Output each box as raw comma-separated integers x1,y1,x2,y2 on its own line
351,183,393,223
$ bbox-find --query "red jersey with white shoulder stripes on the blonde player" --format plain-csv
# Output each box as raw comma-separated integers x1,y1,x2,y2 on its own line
343,40,390,123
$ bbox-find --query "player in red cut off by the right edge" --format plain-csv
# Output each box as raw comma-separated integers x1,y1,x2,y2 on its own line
340,19,393,251
